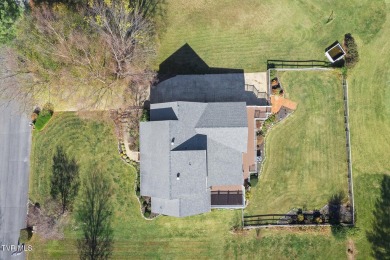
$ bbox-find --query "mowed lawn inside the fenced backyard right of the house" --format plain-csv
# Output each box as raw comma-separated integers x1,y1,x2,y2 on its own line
246,71,348,215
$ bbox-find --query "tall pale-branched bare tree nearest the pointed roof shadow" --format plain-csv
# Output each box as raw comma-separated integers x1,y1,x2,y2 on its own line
89,0,158,108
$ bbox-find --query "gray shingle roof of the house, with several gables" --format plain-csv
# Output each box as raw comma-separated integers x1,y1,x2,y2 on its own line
140,102,247,217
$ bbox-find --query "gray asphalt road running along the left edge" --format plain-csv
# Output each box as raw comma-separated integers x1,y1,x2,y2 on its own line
0,51,31,259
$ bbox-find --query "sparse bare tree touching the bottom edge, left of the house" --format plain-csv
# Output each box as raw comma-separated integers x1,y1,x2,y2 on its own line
77,169,113,259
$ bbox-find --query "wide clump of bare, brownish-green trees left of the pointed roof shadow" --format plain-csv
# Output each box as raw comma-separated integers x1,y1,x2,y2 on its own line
12,0,155,108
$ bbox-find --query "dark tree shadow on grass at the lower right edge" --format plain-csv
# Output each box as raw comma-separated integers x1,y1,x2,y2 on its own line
366,175,390,259
